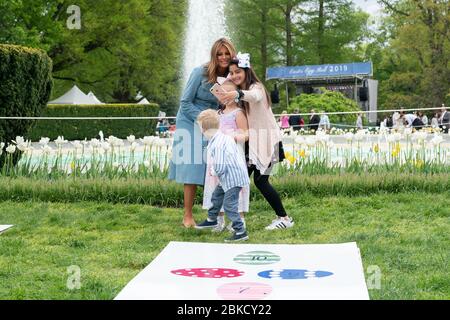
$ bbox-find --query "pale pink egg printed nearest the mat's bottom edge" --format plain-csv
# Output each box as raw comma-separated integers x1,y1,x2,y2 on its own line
217,282,272,300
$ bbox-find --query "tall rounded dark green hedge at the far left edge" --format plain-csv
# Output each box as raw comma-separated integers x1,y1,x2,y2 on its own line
0,44,53,164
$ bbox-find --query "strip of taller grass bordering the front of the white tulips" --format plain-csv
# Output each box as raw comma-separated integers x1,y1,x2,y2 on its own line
0,173,450,207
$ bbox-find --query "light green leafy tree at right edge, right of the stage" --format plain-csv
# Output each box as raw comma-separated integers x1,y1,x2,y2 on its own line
369,0,450,109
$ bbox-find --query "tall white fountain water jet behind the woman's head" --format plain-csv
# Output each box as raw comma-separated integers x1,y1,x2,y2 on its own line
183,0,227,83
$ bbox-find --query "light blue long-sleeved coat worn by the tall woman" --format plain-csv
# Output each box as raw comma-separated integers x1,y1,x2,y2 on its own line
169,67,219,186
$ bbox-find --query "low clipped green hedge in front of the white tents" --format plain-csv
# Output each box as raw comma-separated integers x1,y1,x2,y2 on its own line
28,104,159,141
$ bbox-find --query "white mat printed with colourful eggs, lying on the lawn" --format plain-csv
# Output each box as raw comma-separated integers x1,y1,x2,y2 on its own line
115,242,369,300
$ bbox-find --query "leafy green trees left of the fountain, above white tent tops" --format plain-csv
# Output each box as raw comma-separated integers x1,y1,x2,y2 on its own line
0,0,187,110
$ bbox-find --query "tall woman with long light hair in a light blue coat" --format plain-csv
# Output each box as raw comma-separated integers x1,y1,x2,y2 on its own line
169,38,236,228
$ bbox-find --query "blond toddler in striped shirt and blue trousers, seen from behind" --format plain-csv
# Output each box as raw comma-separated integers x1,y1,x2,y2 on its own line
196,109,250,242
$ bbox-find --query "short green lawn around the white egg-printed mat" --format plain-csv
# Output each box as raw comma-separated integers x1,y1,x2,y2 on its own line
0,193,450,299
